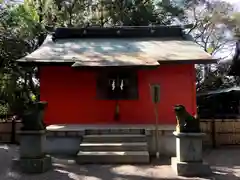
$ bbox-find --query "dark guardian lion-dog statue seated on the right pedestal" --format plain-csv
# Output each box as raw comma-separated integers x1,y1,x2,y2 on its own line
174,105,201,133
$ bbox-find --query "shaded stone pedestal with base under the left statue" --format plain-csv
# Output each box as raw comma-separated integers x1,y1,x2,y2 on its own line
14,130,52,173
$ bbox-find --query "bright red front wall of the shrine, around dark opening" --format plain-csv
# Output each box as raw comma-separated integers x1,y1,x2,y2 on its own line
40,64,196,124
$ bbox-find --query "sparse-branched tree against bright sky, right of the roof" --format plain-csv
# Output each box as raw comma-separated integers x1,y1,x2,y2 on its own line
186,1,239,92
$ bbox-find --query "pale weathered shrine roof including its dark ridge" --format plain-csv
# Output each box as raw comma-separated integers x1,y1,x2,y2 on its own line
18,26,214,66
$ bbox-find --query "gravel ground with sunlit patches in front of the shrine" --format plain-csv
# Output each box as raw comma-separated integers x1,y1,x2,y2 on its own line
0,144,240,180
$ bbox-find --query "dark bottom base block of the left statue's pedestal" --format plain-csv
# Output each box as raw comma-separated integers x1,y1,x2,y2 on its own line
13,156,52,173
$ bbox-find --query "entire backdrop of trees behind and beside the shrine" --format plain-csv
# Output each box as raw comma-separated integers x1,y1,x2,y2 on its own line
0,0,239,116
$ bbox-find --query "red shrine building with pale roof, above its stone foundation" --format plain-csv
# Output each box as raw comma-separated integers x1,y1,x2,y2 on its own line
18,26,216,125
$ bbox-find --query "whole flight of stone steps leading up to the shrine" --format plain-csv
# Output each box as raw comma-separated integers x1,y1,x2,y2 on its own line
76,129,149,164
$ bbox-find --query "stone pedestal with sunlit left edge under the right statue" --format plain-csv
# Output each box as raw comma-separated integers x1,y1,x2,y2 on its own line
171,132,212,177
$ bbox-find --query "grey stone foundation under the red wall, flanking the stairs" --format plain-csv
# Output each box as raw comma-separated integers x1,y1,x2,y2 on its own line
45,125,176,157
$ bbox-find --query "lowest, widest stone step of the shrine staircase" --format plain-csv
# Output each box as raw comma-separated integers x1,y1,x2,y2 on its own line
76,151,149,164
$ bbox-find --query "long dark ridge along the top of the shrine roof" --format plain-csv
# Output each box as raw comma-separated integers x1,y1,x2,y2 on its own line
53,25,184,40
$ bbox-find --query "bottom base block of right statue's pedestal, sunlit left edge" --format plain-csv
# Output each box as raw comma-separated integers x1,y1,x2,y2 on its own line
171,157,212,177
